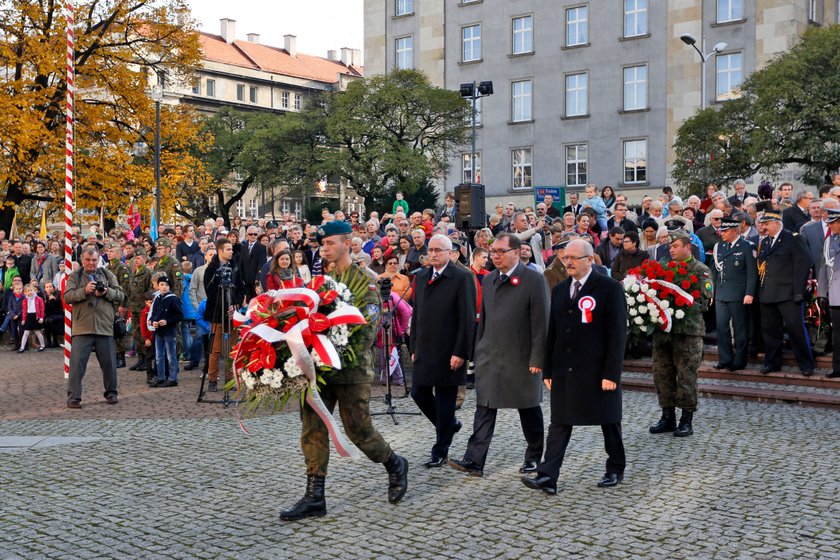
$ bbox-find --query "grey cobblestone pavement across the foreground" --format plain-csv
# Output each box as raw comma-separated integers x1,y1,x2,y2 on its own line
0,352,840,560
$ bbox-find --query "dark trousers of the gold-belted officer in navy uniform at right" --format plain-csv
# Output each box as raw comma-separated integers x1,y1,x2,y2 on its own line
761,300,814,369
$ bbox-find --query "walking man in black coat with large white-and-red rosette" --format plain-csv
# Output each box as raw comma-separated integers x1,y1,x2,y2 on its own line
522,240,627,494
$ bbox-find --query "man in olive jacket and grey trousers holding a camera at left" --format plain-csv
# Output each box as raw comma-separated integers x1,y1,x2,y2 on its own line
64,247,125,408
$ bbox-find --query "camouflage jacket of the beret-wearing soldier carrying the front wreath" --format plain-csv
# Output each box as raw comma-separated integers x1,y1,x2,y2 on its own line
324,264,382,384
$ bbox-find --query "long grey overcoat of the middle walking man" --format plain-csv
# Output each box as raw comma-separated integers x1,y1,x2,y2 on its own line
475,263,549,408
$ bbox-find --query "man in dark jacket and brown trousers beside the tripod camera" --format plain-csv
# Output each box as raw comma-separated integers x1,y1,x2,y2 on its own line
204,237,245,392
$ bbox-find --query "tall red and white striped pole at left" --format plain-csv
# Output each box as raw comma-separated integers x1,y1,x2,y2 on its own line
60,0,76,379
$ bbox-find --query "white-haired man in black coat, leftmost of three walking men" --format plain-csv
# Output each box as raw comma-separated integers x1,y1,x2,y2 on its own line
409,234,476,468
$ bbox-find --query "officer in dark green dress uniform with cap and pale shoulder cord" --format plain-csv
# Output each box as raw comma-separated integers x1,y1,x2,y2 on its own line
712,218,758,371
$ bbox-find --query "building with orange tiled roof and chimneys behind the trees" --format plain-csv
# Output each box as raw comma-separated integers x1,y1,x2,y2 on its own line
159,19,363,218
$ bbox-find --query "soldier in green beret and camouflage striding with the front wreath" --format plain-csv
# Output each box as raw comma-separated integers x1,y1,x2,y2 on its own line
280,222,408,521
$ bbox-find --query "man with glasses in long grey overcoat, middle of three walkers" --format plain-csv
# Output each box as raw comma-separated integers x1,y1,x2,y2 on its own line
449,233,548,476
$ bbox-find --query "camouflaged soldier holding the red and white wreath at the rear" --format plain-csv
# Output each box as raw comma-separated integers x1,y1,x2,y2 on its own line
649,229,714,437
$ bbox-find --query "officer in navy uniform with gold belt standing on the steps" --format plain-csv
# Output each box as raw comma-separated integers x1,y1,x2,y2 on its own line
756,208,814,375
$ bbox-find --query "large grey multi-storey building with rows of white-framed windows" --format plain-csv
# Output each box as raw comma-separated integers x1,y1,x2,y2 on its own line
365,0,840,205
